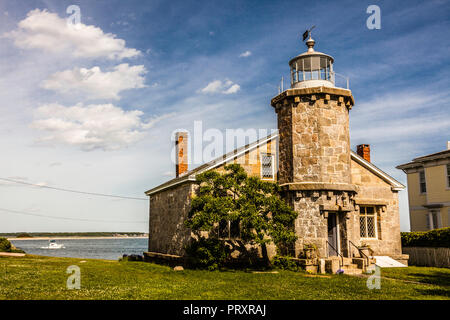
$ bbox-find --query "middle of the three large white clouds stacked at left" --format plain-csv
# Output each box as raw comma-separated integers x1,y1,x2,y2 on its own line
42,63,147,100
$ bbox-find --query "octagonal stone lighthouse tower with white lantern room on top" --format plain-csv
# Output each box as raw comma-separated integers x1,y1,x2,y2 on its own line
271,36,356,256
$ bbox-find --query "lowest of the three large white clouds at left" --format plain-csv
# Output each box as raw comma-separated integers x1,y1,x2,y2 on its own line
32,104,173,151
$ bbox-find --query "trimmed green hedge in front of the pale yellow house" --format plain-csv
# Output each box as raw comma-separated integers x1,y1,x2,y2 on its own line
401,228,450,248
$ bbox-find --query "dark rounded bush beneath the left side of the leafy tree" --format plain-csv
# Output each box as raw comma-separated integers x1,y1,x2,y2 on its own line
186,238,230,270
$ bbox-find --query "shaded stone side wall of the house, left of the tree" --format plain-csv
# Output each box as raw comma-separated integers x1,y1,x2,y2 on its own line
148,182,194,256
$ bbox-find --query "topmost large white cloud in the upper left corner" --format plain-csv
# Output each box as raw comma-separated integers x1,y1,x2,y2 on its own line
4,9,141,60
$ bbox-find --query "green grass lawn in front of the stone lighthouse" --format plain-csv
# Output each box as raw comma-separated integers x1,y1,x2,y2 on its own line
0,256,450,300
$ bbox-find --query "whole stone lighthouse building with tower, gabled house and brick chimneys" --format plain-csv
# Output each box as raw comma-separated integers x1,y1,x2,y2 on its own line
146,37,407,270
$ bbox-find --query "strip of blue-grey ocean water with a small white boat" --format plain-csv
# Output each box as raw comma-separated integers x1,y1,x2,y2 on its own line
11,238,148,260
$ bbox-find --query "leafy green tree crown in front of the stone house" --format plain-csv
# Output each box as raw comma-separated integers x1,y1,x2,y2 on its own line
186,164,297,264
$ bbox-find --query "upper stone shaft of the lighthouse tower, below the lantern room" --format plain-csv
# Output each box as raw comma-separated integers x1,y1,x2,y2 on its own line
272,87,351,184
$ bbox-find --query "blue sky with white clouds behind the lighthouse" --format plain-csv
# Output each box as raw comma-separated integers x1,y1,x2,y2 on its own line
0,0,450,232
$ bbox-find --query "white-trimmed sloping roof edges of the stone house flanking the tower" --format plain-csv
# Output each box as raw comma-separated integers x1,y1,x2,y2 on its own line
145,133,405,196
